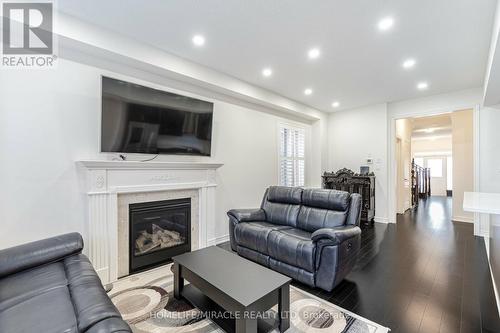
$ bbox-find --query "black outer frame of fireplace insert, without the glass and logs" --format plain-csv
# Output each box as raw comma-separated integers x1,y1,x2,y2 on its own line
128,198,191,274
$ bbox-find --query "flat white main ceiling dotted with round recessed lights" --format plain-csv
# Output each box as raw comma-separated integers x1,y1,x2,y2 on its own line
58,0,496,111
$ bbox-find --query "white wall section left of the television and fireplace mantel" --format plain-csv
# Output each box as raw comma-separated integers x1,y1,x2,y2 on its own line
0,63,99,248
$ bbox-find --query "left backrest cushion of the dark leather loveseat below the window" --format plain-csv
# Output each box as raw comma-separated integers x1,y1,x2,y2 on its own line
261,186,303,227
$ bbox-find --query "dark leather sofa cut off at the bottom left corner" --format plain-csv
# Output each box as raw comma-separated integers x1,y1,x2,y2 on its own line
0,233,132,333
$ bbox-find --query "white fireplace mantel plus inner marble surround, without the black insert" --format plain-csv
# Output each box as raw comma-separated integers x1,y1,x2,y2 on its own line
77,161,222,283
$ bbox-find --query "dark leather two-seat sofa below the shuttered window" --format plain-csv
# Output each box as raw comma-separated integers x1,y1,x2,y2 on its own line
228,186,361,291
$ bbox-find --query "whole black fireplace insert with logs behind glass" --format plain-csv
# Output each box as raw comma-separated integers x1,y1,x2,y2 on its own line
129,198,191,273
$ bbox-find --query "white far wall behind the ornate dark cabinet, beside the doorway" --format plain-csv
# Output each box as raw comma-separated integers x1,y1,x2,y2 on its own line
328,104,388,222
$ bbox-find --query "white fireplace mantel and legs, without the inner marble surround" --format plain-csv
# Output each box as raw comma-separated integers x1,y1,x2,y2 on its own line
77,160,222,283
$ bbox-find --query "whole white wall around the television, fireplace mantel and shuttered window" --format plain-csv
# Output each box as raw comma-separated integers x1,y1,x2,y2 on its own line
0,60,326,248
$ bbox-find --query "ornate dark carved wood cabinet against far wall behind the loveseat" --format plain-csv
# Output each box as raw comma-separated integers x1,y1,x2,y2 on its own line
322,168,375,223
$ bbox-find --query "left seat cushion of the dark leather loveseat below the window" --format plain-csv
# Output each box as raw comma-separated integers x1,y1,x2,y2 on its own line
234,221,289,254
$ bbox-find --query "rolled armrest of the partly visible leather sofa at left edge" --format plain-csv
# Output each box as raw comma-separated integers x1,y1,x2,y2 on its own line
0,232,83,278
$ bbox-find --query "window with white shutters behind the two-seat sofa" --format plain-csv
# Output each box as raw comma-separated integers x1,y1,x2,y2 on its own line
279,125,306,186
